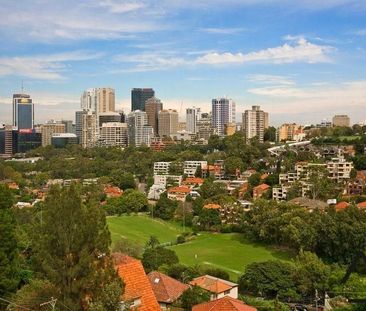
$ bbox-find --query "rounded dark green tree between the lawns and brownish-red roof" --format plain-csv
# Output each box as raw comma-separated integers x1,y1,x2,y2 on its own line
142,246,179,272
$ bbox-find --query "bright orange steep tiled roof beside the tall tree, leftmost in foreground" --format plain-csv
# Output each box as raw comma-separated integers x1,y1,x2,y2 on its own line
113,253,161,311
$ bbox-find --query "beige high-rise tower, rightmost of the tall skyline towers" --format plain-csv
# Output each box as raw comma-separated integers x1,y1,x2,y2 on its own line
242,106,268,142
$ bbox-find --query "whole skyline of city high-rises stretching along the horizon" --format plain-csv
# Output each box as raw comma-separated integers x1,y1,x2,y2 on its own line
0,87,358,156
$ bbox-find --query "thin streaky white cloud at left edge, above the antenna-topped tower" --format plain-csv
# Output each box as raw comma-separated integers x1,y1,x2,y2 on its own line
0,51,101,80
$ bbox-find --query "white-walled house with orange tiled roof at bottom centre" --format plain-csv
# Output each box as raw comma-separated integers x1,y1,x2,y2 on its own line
189,275,238,300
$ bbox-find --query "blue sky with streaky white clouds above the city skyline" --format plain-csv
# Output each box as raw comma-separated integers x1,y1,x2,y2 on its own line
0,0,366,126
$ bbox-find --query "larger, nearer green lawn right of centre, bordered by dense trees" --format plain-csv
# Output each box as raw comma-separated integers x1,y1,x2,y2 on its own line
172,233,291,281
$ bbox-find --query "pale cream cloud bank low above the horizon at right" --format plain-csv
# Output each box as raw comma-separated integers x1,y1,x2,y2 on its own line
247,80,366,123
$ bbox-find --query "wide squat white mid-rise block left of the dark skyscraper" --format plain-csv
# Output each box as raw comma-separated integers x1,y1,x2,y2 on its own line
100,122,128,147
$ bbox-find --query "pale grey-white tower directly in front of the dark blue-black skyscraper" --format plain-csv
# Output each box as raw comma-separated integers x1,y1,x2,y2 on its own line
127,110,152,147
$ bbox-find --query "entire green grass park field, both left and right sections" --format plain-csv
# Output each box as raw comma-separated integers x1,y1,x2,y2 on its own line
107,216,291,281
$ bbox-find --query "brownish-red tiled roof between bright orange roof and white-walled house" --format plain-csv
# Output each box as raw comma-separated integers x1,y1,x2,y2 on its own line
147,271,189,303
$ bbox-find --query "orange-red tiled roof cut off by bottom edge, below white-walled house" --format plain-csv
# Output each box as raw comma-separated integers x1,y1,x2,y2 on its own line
192,296,257,311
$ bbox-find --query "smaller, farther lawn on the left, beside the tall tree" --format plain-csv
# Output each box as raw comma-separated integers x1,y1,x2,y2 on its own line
107,215,182,245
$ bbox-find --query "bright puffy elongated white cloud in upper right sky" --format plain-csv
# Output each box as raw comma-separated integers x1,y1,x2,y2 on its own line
197,38,334,65
